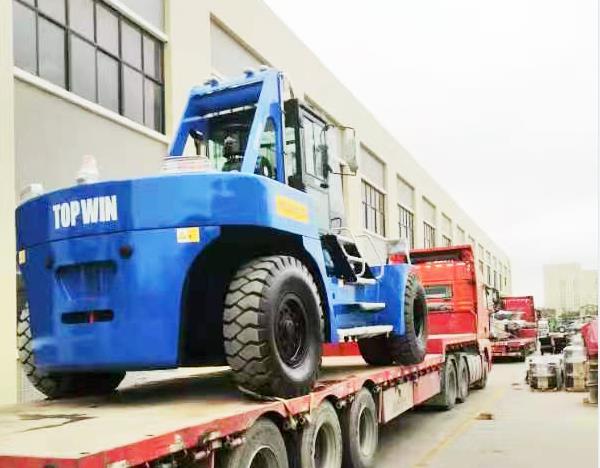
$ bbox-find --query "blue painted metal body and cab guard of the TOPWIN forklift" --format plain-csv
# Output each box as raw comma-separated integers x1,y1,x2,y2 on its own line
16,70,409,371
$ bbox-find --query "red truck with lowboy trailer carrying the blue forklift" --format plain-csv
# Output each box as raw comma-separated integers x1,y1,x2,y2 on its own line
0,246,491,468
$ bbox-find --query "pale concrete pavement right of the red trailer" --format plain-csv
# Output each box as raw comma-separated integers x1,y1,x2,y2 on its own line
376,363,598,468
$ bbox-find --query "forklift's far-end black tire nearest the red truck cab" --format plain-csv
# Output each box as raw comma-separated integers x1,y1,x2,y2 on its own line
358,273,427,366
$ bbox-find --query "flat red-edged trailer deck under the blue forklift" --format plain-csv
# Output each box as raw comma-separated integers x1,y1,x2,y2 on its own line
0,354,444,468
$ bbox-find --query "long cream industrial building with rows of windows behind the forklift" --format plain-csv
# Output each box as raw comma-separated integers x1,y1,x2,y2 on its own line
0,0,510,404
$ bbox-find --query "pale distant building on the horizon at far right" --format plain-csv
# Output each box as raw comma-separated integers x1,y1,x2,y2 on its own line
544,263,598,312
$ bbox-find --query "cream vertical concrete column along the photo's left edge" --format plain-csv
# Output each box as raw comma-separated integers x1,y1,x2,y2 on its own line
0,1,18,405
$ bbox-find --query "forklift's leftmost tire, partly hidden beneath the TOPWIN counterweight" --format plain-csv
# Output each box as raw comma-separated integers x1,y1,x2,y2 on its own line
17,308,125,399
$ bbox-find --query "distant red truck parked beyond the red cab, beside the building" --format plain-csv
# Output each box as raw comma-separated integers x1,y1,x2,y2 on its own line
492,296,538,360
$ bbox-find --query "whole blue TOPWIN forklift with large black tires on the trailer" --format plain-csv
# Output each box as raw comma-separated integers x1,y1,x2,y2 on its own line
16,69,427,398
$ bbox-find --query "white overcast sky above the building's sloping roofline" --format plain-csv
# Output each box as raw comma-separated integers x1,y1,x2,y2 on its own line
266,0,598,305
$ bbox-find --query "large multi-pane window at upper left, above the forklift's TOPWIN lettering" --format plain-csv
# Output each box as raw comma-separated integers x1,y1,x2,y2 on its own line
13,0,164,132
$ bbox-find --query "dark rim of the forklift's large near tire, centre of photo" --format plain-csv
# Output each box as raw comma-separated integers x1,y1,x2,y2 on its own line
275,293,307,367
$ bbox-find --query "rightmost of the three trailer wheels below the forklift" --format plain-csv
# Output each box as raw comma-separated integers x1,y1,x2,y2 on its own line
342,388,379,468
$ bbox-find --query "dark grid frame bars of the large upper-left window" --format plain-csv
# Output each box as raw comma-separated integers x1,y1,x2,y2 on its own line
11,0,166,135
